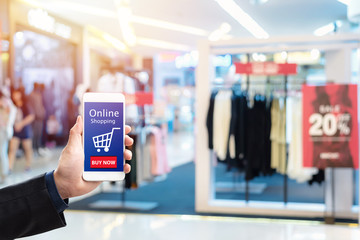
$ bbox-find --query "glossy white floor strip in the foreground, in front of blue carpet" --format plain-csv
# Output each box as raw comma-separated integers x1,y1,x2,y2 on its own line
25,211,360,240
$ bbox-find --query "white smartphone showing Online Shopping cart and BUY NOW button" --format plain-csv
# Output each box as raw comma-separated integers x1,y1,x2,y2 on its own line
83,93,125,181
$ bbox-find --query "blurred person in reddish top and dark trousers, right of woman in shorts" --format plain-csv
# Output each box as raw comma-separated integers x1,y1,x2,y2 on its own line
28,82,45,156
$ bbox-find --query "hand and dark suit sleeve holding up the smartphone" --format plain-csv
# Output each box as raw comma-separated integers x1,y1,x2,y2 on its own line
0,116,133,240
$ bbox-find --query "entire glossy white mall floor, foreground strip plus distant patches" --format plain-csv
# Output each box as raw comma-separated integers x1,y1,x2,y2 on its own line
0,133,360,240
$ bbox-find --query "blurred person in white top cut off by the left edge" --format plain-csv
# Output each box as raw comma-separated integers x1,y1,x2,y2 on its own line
0,89,16,183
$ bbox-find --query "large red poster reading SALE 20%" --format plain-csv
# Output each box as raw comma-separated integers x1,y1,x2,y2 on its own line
302,84,359,169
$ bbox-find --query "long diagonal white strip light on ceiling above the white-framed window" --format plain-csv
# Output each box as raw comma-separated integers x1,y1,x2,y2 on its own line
215,0,269,38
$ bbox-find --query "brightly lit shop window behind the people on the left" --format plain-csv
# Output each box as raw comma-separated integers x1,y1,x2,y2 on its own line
12,30,76,141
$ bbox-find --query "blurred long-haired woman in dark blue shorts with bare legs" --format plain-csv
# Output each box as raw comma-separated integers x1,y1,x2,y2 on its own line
9,88,35,171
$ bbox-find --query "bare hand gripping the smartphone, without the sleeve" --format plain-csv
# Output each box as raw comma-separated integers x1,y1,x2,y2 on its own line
54,116,133,199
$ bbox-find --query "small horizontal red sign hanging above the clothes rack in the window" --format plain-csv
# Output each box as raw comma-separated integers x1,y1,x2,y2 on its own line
235,62,297,75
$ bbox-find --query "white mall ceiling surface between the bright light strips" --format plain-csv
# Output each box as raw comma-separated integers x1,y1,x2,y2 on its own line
31,0,347,55
